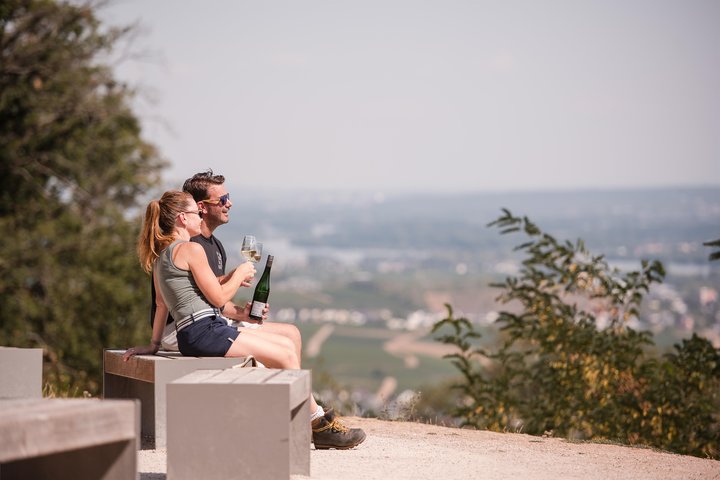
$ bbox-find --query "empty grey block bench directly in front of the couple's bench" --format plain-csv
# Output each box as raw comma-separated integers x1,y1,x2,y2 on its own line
167,368,311,480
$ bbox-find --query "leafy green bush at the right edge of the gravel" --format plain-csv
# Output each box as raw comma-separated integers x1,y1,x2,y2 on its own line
434,210,720,458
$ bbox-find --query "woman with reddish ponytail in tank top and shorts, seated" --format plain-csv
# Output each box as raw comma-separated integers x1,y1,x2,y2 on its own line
123,190,365,449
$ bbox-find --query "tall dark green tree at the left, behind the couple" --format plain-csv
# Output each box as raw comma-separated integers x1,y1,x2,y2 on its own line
0,0,163,393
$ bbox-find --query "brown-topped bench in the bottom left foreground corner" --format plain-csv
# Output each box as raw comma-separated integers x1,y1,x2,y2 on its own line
0,398,140,480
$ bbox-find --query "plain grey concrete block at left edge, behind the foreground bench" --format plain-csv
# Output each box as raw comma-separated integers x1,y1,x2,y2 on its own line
0,347,43,399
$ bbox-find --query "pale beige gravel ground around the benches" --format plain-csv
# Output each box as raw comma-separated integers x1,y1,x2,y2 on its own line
138,417,720,480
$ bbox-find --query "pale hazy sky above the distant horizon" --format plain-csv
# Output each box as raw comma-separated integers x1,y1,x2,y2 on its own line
102,0,720,192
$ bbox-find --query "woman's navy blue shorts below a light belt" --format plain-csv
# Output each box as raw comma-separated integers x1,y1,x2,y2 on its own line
177,316,240,357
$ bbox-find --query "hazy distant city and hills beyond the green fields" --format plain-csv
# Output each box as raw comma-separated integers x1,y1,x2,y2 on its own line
222,188,720,346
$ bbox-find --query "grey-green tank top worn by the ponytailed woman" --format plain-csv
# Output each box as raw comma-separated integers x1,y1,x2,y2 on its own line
154,240,213,321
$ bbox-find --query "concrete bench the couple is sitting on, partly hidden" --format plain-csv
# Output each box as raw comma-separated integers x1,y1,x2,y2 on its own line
103,350,255,448
